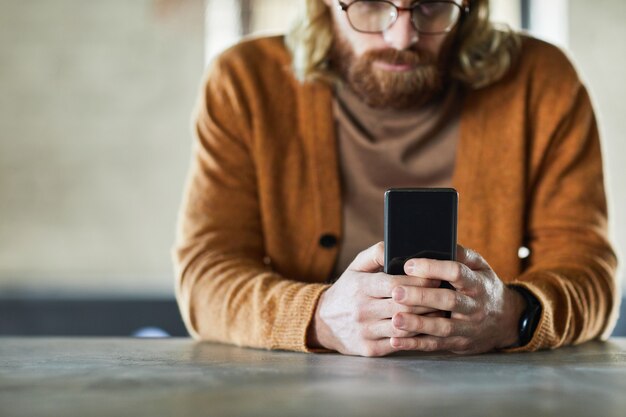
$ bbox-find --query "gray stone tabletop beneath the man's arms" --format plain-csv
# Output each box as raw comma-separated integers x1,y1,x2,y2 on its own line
0,337,626,417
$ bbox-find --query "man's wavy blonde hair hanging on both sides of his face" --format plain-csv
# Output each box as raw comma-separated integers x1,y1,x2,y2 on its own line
286,0,521,89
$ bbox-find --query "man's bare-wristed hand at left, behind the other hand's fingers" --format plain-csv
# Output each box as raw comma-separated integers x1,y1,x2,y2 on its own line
308,242,440,356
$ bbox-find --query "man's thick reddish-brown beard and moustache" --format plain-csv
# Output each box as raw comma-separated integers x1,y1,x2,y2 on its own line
331,33,444,109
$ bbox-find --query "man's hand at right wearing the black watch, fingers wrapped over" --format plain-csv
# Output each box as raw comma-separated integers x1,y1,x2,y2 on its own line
390,246,524,354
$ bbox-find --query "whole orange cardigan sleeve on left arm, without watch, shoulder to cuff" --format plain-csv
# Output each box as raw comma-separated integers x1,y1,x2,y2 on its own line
173,53,328,351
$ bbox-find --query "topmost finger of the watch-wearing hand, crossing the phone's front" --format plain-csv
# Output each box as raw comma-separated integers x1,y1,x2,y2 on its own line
404,258,476,289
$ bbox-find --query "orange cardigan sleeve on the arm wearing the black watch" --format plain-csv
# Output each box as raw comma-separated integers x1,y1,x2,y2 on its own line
502,70,619,351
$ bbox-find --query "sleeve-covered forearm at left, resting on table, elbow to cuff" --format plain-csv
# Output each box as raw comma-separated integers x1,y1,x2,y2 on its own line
177,244,327,351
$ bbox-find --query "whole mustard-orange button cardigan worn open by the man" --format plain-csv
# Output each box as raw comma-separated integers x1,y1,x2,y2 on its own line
174,37,619,351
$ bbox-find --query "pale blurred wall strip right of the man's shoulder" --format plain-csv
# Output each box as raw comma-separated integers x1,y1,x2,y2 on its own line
569,0,626,296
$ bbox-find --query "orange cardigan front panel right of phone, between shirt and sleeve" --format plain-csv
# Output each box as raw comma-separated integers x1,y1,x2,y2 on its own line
453,82,526,278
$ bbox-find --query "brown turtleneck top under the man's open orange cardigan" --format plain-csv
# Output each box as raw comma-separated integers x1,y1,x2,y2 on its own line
333,87,461,279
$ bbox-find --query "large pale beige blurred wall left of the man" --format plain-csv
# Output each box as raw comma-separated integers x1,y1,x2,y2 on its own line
0,0,203,296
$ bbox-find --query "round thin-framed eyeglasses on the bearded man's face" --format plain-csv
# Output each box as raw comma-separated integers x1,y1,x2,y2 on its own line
338,0,469,34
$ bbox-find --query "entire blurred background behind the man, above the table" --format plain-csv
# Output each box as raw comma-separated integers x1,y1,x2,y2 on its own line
0,0,626,336
